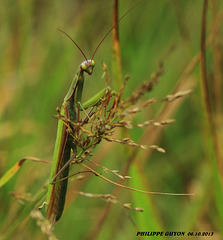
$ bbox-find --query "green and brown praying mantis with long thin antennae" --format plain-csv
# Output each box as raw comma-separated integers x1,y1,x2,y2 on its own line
46,0,144,226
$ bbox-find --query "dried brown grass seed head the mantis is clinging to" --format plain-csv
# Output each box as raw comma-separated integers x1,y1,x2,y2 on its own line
55,63,191,195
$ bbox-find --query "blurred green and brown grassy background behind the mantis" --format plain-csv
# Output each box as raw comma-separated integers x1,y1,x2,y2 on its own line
0,0,223,240
